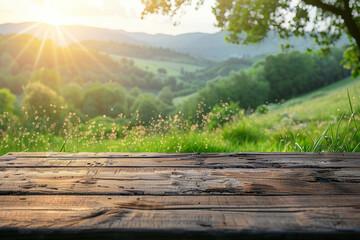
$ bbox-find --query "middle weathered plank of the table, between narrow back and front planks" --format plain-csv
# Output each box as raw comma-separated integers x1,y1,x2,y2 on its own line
0,167,360,195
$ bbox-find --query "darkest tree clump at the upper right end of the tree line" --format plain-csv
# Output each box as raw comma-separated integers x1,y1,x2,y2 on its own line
263,49,349,102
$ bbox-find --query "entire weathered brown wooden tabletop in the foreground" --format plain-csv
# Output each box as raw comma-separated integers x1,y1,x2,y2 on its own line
0,153,360,239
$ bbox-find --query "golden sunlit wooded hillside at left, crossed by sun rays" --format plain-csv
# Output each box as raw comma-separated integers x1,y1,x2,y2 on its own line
0,34,171,94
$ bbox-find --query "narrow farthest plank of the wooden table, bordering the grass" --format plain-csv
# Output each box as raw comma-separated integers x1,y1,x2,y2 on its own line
0,153,360,168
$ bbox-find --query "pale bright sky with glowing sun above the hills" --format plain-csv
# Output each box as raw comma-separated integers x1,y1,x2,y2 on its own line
0,0,219,35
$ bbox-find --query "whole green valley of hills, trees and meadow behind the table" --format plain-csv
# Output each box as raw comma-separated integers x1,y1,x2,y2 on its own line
0,34,360,154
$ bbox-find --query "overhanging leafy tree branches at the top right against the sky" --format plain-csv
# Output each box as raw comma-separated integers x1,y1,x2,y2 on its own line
142,0,360,76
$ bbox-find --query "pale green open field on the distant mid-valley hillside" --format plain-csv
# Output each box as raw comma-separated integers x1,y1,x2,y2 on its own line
110,55,202,77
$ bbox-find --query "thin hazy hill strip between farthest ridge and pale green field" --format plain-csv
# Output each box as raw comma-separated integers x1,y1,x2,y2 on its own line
71,40,215,67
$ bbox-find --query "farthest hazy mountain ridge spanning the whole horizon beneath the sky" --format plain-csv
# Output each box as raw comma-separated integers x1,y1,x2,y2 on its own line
0,23,348,60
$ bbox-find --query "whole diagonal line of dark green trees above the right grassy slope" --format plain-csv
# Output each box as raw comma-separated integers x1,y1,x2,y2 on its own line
180,48,351,121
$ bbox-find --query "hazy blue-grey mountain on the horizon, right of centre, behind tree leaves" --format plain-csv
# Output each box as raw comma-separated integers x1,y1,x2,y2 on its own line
128,32,348,60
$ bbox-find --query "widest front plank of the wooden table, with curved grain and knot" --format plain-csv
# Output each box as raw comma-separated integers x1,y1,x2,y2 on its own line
0,195,360,232
